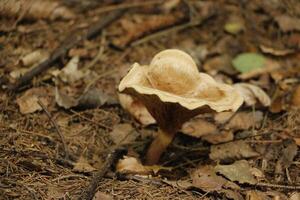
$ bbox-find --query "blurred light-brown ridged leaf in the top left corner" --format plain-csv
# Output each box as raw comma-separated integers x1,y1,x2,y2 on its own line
0,0,75,20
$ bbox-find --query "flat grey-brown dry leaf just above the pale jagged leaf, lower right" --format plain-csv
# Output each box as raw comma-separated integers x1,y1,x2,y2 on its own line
209,141,259,161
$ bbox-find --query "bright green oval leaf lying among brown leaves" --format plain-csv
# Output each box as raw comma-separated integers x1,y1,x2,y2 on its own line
232,53,266,73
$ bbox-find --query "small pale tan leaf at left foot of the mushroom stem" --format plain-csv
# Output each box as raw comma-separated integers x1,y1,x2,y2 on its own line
116,156,150,174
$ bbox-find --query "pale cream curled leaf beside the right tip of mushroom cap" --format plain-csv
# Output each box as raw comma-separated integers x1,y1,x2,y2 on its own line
233,83,271,106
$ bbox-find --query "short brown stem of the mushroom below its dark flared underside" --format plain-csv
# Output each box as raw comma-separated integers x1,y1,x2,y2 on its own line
146,129,175,165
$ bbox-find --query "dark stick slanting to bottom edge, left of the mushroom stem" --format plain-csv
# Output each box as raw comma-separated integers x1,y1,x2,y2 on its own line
78,149,123,200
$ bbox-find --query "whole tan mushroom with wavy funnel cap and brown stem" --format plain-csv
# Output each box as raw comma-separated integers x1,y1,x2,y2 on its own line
118,49,243,165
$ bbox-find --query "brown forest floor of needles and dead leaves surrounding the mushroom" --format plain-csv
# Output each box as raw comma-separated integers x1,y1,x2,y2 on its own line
0,0,300,200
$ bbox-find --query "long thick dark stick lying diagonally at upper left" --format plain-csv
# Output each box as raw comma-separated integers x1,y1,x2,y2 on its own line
10,9,125,91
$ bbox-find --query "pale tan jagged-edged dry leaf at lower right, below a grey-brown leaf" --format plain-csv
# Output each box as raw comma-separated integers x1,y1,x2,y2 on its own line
215,160,257,184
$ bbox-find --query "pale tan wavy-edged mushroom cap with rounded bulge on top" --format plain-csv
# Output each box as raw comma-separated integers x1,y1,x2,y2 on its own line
119,49,243,112
